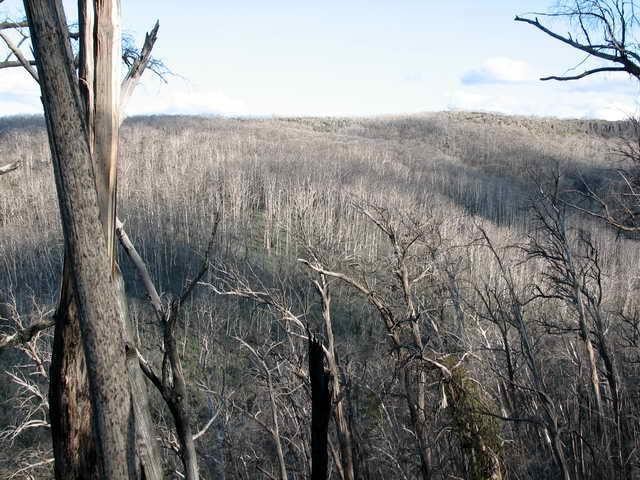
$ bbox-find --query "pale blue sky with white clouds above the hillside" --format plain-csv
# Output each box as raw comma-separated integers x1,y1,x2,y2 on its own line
0,0,640,120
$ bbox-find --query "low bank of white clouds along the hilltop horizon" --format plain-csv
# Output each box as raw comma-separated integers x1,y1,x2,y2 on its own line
0,57,640,120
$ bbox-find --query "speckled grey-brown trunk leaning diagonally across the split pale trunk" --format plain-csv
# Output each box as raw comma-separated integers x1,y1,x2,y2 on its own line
24,0,130,479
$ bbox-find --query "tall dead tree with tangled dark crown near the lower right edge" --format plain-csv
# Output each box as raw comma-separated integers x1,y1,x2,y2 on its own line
525,175,632,478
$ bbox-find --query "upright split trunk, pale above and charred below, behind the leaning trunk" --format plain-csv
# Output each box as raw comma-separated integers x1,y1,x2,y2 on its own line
37,0,163,480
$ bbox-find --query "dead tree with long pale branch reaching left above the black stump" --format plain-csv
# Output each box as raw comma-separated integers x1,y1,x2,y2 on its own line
300,204,502,480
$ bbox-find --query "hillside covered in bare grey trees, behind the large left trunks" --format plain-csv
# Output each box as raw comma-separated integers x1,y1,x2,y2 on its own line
0,112,640,479
